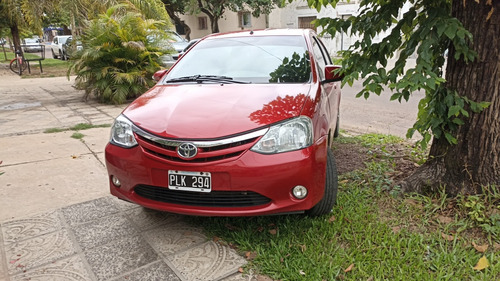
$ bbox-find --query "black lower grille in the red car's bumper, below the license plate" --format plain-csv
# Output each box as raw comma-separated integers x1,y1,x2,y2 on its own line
134,185,271,207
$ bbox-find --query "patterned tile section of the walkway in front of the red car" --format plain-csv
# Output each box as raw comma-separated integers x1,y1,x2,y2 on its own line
0,196,247,281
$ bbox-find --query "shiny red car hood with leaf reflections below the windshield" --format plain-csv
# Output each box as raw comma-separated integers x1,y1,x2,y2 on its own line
123,84,311,139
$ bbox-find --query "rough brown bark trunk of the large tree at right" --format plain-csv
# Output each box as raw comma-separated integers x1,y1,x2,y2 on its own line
401,0,500,196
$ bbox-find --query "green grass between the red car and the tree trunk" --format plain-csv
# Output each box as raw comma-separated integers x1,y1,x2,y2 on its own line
186,135,500,280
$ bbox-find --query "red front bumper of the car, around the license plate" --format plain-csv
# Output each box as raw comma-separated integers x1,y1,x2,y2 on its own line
105,139,327,216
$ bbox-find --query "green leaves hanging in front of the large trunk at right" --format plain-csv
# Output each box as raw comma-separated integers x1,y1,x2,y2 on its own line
309,0,489,149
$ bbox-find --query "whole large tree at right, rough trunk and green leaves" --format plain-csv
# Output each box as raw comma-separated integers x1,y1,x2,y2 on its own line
308,0,500,195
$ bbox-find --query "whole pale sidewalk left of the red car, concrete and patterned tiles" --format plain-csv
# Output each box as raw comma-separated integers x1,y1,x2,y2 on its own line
0,65,250,281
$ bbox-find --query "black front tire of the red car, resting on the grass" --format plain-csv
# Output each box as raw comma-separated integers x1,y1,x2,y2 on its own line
306,148,339,217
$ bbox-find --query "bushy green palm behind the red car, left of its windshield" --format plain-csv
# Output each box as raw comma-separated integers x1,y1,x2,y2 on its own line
68,5,168,104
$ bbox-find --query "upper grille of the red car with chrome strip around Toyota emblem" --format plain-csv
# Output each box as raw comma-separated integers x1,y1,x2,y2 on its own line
134,127,267,163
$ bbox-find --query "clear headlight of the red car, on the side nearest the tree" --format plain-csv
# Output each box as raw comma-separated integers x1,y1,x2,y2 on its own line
250,116,313,154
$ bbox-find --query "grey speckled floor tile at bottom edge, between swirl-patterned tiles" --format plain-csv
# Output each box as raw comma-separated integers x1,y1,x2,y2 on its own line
84,236,158,280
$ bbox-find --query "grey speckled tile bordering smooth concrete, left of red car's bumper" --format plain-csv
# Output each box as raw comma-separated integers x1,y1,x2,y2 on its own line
62,197,119,226
